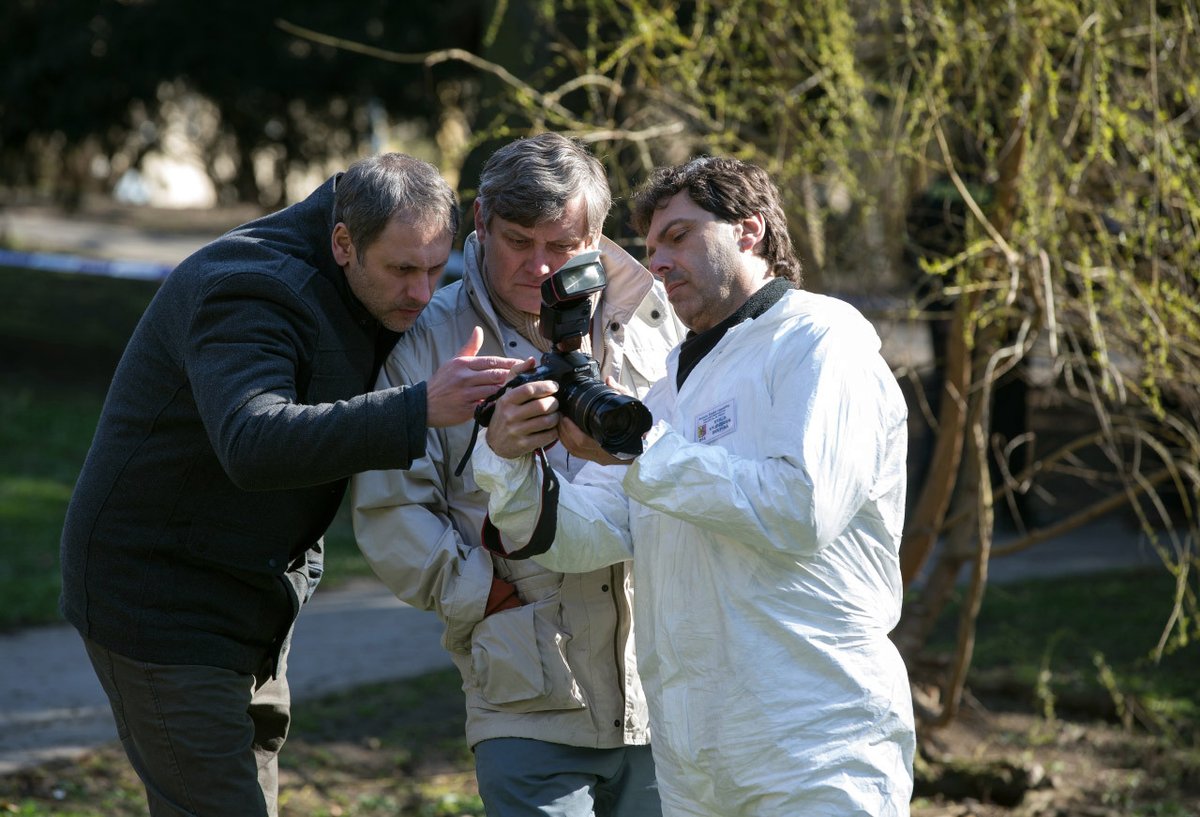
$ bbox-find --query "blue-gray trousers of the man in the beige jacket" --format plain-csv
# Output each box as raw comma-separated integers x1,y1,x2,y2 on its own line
475,738,662,817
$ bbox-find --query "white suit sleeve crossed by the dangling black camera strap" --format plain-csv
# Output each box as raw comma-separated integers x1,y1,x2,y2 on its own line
472,432,634,573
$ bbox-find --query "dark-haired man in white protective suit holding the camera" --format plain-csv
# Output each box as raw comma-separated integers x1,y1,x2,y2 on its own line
474,157,916,817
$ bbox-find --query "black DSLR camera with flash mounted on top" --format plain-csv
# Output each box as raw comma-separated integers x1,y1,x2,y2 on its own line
475,250,654,457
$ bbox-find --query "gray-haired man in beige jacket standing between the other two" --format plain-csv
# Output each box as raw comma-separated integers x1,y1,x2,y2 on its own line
353,133,682,817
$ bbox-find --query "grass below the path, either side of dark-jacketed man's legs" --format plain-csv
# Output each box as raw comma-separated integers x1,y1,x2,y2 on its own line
0,669,484,817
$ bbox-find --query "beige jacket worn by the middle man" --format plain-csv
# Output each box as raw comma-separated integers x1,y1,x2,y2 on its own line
352,234,683,749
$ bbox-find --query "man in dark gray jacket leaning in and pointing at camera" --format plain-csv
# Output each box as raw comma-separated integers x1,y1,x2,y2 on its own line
61,154,515,817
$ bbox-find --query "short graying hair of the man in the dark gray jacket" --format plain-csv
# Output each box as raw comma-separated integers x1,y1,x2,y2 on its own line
334,154,458,256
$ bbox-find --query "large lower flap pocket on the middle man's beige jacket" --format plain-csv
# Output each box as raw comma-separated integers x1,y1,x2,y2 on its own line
472,599,587,713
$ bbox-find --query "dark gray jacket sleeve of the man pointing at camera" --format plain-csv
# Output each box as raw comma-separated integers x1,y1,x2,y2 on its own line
182,272,426,491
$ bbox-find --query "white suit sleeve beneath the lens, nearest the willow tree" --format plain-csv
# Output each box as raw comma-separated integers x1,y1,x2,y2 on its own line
624,328,906,554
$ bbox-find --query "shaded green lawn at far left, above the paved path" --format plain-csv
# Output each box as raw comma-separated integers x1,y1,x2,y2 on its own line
0,268,155,630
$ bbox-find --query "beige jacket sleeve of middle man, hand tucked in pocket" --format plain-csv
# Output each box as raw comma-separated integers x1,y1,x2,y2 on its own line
350,347,492,653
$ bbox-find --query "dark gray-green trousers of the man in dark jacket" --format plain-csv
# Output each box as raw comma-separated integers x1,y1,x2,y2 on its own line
83,638,290,817
